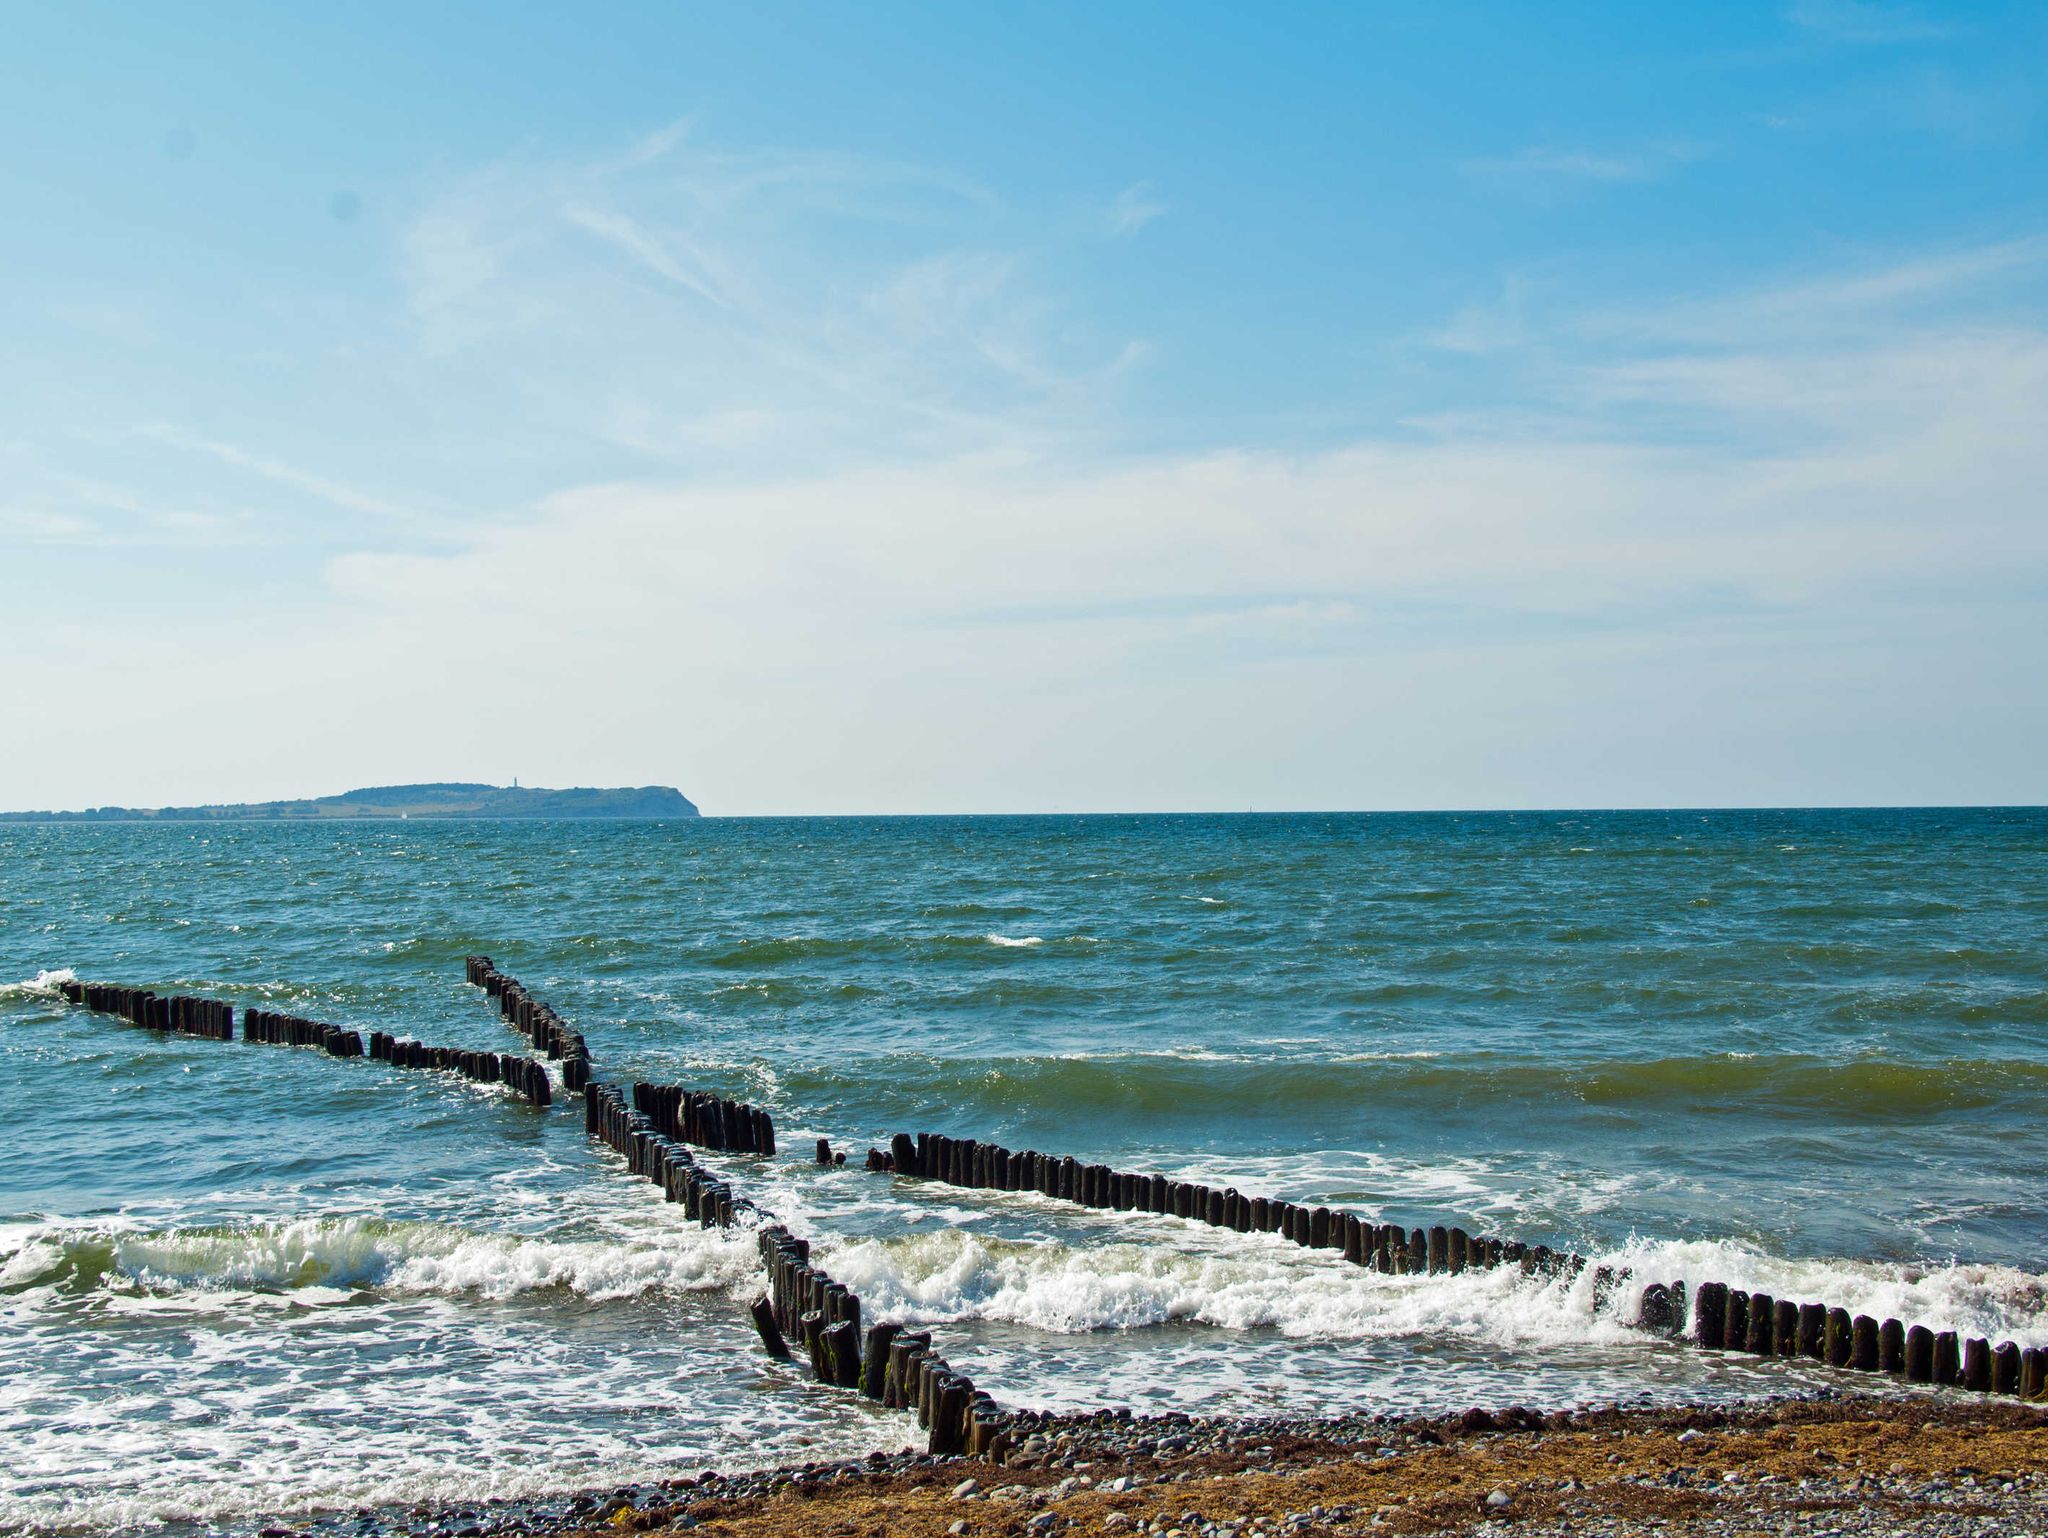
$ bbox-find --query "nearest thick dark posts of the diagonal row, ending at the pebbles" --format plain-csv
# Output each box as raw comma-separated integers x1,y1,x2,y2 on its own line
752,1223,1008,1456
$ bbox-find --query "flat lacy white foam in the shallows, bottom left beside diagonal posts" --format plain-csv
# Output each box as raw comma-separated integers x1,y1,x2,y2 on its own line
0,1298,909,1530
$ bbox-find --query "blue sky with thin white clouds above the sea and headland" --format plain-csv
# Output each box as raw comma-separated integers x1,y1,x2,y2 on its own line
0,0,2048,815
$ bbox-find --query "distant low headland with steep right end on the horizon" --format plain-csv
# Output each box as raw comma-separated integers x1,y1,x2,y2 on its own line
0,784,698,823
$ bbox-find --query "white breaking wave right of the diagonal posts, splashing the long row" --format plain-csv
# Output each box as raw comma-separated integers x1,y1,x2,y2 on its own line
825,1229,2048,1348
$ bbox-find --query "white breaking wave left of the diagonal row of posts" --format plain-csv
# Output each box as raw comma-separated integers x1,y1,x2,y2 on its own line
0,1216,756,1300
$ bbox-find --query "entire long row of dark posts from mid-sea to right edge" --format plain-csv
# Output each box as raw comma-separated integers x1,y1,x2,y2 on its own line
866,1133,2048,1399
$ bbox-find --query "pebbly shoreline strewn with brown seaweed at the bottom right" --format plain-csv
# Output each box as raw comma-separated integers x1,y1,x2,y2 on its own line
276,1393,2048,1538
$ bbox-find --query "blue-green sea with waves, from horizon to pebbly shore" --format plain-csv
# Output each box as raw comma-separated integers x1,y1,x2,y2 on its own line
0,809,2048,1532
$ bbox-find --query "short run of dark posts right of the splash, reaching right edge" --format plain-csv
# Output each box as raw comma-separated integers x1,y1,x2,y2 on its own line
1692,1282,2048,1399
